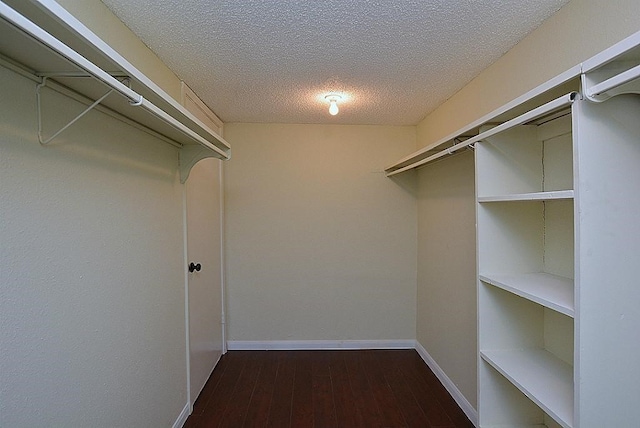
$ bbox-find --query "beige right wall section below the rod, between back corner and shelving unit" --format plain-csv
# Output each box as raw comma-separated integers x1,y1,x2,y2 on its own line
416,151,477,406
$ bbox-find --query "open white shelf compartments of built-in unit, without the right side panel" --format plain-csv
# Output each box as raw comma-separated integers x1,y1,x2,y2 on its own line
476,101,575,428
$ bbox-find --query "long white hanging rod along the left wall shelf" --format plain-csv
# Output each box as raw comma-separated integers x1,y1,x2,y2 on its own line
0,1,229,159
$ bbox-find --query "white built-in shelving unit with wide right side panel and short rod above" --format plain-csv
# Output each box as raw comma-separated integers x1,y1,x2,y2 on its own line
475,30,640,428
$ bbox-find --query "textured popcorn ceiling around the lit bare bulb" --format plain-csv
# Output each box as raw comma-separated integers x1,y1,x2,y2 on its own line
103,0,568,125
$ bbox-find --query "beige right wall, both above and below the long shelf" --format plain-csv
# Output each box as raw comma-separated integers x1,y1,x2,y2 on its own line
417,0,640,412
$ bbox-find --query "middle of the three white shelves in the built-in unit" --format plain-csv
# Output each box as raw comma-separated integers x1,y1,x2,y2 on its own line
480,273,575,318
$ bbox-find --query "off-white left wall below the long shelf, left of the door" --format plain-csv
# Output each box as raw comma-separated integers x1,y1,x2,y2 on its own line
0,62,187,427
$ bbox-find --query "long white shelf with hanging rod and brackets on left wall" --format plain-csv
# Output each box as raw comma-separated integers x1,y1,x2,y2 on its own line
0,0,230,182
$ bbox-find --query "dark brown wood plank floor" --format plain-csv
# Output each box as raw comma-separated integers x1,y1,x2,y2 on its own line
185,350,473,428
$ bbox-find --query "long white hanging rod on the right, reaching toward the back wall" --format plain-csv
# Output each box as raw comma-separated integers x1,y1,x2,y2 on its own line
386,92,579,177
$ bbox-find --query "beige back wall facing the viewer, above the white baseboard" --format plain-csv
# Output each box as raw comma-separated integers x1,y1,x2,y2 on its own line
225,124,417,341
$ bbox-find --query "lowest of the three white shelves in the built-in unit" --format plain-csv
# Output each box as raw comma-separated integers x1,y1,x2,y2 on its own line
480,349,573,428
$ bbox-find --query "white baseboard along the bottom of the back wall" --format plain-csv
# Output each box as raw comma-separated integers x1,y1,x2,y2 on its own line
227,340,416,351
